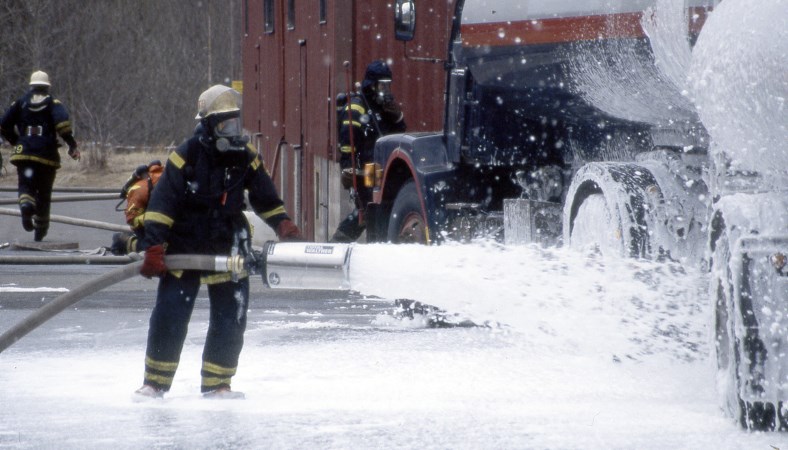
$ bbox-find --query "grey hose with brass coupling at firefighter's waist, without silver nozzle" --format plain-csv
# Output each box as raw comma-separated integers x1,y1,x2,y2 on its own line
0,255,243,353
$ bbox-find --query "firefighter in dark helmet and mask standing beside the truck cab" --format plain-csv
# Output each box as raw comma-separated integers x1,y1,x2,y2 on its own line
331,60,406,242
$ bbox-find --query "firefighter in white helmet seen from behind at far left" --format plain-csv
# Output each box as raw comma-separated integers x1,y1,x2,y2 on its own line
0,70,80,242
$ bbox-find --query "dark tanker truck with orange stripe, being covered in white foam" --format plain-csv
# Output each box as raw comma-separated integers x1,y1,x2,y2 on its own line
364,0,788,429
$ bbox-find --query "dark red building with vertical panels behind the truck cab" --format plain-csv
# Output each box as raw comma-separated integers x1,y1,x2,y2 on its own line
242,0,454,241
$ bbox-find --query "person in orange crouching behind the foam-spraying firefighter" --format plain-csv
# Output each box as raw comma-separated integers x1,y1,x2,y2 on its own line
110,159,164,255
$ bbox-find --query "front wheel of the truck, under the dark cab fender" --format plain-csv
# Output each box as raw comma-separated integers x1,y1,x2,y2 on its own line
388,181,427,244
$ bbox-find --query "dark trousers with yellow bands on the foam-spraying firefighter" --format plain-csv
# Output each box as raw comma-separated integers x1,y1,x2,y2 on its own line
144,271,249,392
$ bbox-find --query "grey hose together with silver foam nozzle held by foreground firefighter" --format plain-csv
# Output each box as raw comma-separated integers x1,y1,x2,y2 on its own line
0,241,352,353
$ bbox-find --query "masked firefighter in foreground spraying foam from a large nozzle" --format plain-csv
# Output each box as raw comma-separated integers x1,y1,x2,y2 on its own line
136,85,301,398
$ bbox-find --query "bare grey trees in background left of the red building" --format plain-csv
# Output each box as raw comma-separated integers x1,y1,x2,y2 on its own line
0,0,240,149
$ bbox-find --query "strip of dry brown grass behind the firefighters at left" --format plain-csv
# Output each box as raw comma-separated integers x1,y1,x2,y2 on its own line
0,146,170,189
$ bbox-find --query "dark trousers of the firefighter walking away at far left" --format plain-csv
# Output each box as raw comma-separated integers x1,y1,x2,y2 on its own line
16,161,57,234
